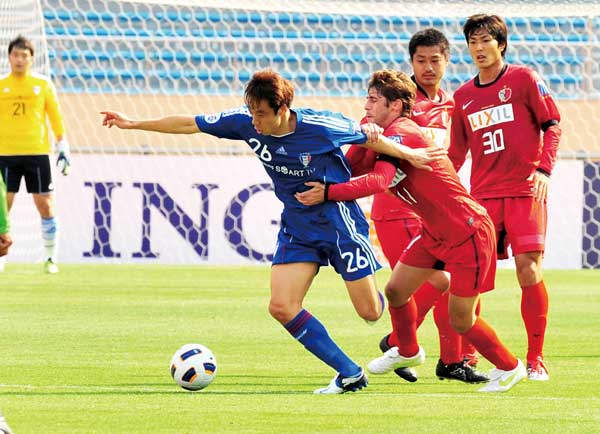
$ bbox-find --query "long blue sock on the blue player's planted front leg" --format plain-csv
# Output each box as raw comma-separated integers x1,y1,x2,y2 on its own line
284,309,361,377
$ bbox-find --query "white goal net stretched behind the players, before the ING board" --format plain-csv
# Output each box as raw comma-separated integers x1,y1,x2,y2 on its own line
0,0,600,268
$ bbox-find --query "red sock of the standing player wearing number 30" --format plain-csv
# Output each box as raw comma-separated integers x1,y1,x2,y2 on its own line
521,280,548,360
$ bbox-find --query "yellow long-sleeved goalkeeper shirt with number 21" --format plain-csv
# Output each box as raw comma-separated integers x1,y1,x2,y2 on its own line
0,74,65,155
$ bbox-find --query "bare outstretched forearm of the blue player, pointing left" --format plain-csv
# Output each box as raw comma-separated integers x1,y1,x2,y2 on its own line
100,110,200,134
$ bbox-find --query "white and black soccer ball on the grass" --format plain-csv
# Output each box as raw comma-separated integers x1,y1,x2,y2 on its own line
171,344,217,390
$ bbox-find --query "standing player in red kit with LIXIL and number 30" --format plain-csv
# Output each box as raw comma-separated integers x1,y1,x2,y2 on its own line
448,14,561,381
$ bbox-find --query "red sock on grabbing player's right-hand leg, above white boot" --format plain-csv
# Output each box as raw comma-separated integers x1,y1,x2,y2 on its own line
463,317,517,371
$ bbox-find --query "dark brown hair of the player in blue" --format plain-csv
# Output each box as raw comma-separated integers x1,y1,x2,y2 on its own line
244,69,294,113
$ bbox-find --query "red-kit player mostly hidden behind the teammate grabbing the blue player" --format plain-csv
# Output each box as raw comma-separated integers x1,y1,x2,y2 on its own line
346,28,487,383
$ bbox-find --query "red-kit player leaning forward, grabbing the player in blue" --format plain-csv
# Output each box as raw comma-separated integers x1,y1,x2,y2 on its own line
296,70,527,392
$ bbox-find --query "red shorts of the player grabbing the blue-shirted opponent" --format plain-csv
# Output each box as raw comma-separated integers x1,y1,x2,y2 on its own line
400,218,497,297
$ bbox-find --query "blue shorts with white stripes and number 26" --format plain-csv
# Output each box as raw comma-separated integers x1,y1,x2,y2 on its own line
273,202,381,281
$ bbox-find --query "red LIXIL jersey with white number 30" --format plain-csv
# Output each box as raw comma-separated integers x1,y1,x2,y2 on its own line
448,65,560,199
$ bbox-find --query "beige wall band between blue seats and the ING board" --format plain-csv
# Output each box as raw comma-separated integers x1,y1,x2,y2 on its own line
60,94,600,157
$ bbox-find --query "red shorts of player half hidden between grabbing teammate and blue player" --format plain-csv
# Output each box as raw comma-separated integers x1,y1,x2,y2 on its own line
373,218,422,268
